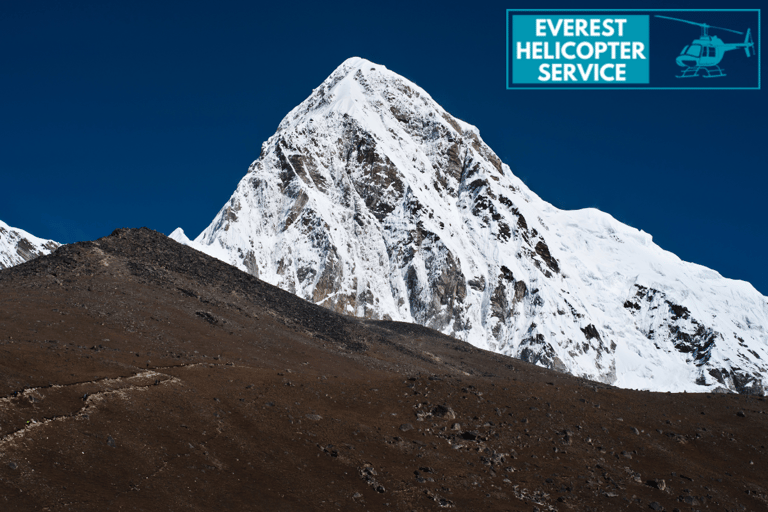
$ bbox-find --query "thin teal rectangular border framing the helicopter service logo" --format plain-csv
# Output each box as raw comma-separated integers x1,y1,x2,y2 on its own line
506,9,763,91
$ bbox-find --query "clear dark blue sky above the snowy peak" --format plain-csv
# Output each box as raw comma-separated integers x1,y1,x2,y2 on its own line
0,0,768,294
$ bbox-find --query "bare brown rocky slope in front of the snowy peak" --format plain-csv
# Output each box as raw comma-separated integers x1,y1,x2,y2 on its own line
0,229,768,511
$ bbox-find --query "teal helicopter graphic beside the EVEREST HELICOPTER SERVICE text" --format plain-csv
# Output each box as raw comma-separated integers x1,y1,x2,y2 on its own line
656,14,755,78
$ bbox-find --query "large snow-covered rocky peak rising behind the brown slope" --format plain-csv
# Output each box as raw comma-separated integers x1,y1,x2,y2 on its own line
171,58,768,394
